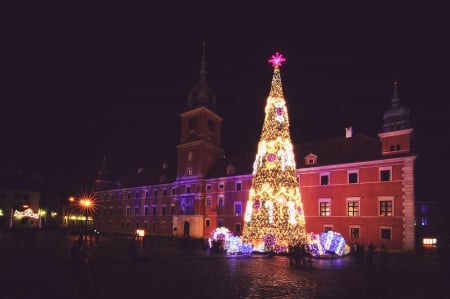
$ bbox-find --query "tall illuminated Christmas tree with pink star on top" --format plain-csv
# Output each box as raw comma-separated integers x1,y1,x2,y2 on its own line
242,52,307,252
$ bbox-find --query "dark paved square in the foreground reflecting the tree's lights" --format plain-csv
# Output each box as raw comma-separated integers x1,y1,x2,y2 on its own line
0,231,450,299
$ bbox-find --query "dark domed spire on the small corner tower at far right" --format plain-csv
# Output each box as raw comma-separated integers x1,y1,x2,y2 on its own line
383,80,410,132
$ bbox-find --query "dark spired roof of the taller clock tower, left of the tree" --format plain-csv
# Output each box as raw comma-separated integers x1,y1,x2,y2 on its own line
188,42,216,110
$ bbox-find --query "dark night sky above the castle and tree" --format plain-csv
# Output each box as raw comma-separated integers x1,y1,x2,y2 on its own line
0,1,450,204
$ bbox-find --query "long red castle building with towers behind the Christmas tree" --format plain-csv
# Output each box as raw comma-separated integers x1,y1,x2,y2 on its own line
94,45,416,251
